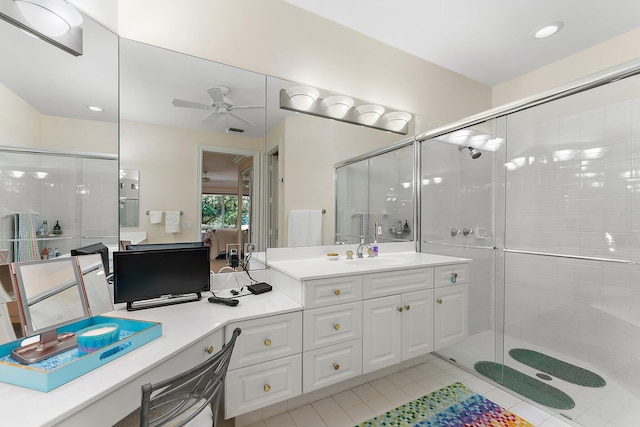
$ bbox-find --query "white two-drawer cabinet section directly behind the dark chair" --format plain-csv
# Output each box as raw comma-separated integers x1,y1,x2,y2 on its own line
225,311,302,418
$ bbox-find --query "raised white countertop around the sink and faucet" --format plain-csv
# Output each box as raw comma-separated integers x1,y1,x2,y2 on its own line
267,251,471,280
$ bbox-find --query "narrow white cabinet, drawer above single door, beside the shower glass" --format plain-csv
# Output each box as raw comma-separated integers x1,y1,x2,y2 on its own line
434,264,469,350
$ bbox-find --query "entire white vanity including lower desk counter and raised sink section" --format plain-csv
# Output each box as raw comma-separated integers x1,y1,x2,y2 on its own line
0,246,469,426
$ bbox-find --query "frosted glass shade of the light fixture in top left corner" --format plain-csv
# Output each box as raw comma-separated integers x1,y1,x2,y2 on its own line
14,0,82,37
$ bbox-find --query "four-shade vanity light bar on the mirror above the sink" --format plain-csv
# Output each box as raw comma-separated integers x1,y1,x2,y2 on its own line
280,85,413,135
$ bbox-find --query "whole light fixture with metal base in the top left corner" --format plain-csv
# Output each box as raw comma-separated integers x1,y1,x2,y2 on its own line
0,0,83,56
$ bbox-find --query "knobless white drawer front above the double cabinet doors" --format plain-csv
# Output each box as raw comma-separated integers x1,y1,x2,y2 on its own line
362,267,433,299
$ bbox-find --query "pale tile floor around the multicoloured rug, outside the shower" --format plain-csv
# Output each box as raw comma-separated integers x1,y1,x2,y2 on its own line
235,358,577,427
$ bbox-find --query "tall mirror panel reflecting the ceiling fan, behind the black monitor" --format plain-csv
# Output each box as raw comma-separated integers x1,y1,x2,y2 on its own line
120,39,265,270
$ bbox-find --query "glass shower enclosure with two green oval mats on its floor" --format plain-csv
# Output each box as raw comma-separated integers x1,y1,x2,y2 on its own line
419,64,640,427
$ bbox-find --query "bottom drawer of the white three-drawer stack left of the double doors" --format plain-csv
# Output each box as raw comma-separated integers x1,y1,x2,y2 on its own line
302,339,362,393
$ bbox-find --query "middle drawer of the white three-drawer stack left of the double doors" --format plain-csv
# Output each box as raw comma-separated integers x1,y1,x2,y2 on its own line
302,301,362,351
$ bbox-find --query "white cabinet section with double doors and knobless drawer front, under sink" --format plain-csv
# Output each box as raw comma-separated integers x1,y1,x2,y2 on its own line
362,268,433,373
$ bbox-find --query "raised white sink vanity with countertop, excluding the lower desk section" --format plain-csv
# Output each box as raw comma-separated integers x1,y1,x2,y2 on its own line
269,245,470,404
